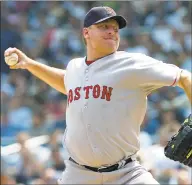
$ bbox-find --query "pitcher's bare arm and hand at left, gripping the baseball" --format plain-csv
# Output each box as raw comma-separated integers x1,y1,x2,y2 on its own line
4,48,67,94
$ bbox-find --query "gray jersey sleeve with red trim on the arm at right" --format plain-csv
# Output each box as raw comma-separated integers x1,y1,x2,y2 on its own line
135,54,182,93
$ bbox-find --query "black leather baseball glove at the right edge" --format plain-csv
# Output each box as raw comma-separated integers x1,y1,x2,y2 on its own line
164,114,192,167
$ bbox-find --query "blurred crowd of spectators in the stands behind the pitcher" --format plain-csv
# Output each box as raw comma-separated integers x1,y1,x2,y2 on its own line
1,1,192,184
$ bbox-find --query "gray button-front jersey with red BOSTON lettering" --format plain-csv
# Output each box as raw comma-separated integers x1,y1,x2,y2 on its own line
64,51,181,167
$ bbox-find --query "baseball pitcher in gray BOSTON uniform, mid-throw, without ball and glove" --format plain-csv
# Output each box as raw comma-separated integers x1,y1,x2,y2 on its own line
5,7,192,184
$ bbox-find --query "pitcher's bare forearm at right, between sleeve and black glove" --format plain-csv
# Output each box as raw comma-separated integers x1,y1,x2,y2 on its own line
178,70,192,105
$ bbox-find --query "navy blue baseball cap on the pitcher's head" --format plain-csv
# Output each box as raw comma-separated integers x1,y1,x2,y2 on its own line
84,6,127,29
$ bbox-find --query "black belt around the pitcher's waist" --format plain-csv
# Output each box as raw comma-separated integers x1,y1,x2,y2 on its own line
69,157,133,173
